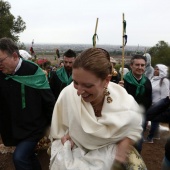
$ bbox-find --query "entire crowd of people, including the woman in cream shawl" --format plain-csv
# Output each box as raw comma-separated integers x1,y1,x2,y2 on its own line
0,38,170,170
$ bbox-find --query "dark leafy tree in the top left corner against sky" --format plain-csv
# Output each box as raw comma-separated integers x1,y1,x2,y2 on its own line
0,0,26,42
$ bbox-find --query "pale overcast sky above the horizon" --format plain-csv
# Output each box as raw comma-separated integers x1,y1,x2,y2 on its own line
7,0,170,46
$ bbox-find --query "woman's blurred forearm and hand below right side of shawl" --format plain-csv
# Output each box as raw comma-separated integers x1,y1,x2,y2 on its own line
115,138,133,163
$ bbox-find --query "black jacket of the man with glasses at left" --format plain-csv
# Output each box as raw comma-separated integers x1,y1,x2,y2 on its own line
0,61,55,146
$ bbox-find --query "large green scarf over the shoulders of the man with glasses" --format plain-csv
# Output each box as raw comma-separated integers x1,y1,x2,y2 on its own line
5,60,50,109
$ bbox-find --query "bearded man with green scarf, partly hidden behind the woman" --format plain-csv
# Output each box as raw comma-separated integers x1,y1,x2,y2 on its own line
50,49,76,100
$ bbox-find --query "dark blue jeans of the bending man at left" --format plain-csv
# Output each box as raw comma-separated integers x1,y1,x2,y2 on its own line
13,141,41,170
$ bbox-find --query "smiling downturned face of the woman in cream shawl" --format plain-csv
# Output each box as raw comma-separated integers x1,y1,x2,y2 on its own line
72,68,110,104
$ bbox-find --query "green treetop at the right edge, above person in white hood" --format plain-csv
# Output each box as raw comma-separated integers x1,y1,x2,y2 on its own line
148,41,170,66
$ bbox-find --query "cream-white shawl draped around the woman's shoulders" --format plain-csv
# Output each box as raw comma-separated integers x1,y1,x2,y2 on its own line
50,82,142,150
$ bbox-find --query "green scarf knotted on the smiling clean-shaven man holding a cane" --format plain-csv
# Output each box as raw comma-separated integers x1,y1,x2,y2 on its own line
124,71,146,96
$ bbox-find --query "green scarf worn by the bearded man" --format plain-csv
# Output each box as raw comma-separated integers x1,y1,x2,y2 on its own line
56,67,72,85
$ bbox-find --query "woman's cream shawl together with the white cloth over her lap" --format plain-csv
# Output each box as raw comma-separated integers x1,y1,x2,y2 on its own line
50,82,142,170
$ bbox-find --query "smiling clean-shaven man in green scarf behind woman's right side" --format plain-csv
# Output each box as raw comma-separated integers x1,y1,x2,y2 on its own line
119,55,152,153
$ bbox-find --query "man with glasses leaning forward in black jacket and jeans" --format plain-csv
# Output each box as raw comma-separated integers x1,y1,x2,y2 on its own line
0,38,55,170
